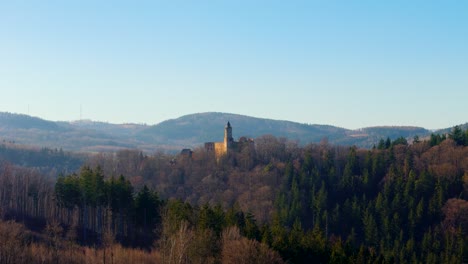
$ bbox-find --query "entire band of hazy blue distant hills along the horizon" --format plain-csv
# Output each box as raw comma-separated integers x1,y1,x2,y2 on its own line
0,112,460,153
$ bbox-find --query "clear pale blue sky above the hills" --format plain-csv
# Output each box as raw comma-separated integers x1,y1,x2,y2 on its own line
0,0,468,128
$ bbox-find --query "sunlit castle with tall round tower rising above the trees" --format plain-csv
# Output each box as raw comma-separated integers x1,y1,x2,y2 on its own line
205,121,254,159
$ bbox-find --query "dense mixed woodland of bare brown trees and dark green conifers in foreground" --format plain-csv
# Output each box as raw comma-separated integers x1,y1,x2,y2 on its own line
0,127,468,263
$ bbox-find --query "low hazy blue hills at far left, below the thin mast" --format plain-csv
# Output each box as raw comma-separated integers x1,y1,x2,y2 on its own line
0,113,148,152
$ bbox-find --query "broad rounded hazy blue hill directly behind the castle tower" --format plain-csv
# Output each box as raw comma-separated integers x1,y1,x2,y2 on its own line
139,112,347,145
